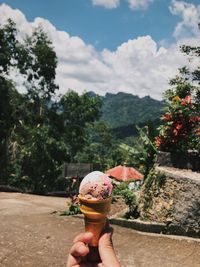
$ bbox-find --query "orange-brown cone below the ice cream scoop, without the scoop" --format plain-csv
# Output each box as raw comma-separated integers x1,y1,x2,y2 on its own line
79,195,111,247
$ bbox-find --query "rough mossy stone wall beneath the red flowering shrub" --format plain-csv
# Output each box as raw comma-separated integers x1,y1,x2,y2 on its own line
139,166,200,237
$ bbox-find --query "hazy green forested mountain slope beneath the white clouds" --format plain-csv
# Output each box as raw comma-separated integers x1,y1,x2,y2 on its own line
102,93,163,128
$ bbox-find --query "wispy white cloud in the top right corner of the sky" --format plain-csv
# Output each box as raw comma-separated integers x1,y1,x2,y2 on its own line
170,0,200,38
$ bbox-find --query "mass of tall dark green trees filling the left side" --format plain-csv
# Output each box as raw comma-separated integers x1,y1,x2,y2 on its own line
0,20,101,192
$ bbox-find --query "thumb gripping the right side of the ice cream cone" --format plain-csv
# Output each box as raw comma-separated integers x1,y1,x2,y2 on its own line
99,227,120,267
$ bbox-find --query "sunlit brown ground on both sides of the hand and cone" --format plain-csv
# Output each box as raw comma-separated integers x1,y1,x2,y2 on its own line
0,193,200,267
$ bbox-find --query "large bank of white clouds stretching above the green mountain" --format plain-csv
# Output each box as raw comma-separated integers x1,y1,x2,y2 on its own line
0,5,196,99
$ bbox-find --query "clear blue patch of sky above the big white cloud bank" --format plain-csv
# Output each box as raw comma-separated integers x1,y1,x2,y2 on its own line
2,0,185,50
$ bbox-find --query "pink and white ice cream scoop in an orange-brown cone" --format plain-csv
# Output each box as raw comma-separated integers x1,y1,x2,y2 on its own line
79,171,113,247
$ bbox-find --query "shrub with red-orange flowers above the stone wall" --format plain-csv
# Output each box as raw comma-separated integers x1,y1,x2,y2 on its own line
155,93,200,151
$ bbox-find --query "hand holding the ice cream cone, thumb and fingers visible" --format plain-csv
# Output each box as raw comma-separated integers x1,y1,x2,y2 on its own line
67,227,120,267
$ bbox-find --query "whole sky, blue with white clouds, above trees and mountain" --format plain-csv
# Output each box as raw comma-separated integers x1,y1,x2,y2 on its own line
0,0,200,99
